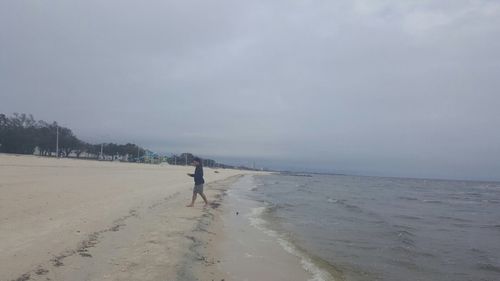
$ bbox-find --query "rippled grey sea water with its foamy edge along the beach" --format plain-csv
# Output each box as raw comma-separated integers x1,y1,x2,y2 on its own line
240,174,500,281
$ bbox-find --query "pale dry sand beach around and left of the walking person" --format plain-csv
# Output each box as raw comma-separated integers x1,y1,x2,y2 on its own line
0,154,258,281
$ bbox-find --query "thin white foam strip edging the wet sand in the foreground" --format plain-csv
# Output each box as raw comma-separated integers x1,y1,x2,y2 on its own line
249,207,335,281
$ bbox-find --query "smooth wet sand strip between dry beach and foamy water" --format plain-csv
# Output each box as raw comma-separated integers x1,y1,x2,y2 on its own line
192,175,322,281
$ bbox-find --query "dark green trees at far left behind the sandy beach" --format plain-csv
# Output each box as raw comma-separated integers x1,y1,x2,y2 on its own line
0,113,145,161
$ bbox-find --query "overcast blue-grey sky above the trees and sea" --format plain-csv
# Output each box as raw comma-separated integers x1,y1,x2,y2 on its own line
0,0,500,180
